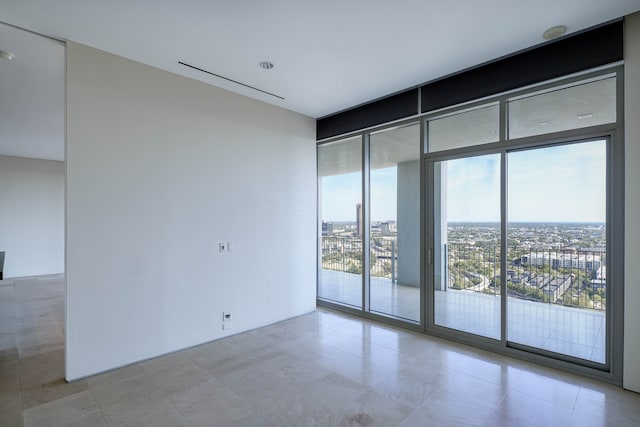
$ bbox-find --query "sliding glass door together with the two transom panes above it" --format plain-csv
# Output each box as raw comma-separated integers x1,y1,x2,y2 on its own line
424,74,622,370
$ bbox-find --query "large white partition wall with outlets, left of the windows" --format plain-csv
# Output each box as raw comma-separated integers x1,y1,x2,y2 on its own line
66,42,316,380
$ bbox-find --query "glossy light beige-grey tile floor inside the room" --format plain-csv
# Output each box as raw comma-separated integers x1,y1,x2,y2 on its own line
0,277,640,427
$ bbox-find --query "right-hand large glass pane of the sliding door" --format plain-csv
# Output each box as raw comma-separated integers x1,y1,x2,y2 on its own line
507,141,607,363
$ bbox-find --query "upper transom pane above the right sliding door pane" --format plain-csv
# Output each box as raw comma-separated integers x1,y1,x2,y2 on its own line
508,77,616,139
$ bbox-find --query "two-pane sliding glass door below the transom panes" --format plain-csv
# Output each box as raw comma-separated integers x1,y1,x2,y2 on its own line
428,139,608,364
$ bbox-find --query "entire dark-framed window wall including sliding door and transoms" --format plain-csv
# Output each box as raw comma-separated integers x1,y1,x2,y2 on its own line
318,69,624,382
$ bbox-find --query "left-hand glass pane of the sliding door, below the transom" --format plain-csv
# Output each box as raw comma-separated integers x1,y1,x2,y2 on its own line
433,154,501,339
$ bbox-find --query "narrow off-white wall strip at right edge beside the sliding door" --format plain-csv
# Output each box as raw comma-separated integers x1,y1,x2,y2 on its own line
623,13,640,392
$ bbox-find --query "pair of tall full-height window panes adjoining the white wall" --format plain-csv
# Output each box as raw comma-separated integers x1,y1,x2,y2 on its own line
318,121,421,323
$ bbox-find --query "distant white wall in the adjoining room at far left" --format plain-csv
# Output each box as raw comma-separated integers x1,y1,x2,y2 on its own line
0,156,64,278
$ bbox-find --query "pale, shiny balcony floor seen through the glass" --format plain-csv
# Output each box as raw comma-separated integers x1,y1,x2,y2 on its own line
318,269,606,363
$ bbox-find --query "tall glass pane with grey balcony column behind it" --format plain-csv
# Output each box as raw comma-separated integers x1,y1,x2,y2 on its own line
369,123,420,321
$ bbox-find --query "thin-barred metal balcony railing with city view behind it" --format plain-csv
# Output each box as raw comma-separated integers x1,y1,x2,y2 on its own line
322,235,606,311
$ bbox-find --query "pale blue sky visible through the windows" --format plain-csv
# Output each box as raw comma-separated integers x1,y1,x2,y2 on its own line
322,141,606,226
